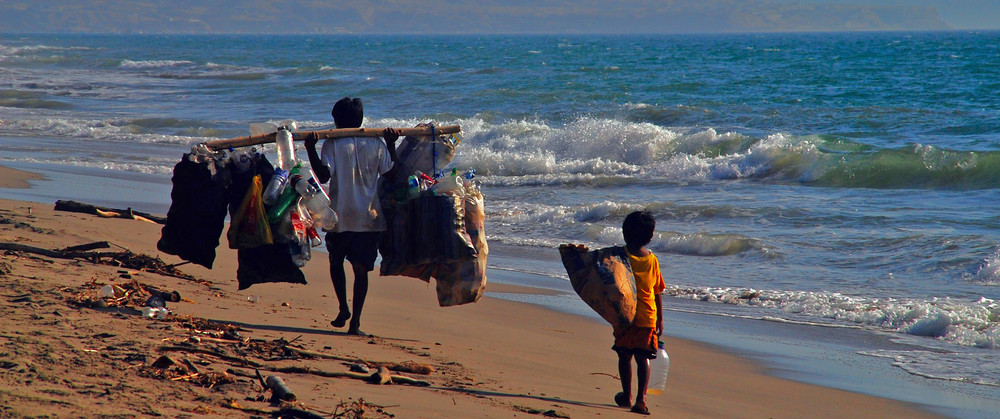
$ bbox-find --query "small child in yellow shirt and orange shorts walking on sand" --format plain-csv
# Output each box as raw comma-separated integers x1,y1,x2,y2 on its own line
611,211,666,415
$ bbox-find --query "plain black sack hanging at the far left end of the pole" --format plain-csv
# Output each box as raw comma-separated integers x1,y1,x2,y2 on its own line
156,154,231,269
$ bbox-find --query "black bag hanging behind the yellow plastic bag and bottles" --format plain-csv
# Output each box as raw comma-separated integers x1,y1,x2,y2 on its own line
226,155,306,290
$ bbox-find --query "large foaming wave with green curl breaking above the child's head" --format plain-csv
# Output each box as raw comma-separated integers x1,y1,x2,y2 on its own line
446,117,1000,189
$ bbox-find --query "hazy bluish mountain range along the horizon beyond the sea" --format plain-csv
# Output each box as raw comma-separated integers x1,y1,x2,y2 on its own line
0,0,949,34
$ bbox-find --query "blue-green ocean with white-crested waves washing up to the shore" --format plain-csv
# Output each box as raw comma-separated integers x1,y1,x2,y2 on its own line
0,32,1000,417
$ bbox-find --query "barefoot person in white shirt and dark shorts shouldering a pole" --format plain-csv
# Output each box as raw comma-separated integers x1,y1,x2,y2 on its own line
305,97,399,336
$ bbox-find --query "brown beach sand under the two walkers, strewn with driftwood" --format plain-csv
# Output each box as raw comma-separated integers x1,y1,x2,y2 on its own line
0,166,937,418
